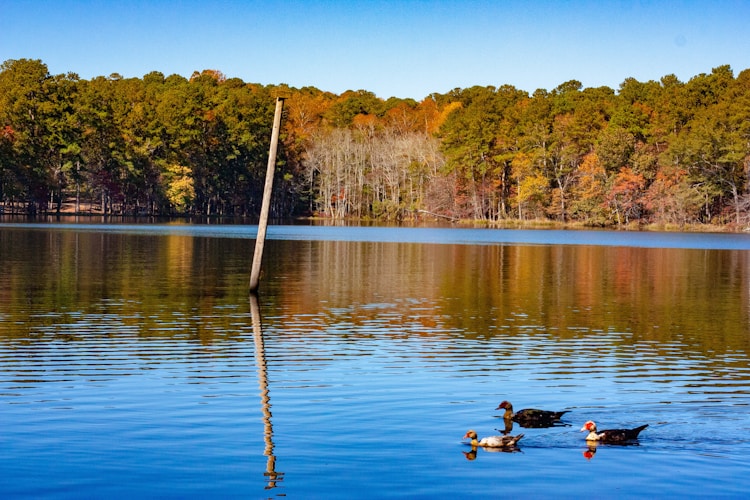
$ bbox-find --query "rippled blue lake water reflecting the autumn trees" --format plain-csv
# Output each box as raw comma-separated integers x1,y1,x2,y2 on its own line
0,223,750,498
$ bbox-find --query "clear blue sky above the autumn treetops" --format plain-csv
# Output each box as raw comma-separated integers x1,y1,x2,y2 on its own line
0,0,750,100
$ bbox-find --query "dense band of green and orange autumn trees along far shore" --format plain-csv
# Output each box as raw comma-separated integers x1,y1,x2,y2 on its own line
0,59,750,228
